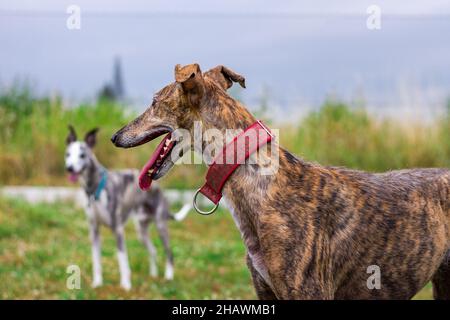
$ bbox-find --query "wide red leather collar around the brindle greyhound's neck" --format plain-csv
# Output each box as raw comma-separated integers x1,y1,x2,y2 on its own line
198,120,274,205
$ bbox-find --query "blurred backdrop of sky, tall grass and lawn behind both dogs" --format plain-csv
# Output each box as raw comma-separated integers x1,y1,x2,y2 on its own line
0,0,450,299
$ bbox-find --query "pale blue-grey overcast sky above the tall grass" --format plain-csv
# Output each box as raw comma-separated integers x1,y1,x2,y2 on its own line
0,0,450,119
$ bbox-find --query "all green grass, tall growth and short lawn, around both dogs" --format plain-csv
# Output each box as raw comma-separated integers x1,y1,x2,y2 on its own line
0,87,450,299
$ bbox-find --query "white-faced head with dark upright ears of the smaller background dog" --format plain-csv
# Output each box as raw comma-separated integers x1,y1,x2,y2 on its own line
65,125,98,182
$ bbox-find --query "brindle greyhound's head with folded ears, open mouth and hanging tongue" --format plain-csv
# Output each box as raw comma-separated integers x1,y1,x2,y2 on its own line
111,64,248,189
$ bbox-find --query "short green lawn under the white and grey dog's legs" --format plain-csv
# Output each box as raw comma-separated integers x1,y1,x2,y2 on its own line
0,199,432,299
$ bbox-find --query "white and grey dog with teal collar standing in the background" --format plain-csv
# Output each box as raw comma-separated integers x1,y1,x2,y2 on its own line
65,126,190,290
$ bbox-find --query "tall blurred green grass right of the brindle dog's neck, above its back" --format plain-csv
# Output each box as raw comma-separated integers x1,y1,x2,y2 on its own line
280,101,450,172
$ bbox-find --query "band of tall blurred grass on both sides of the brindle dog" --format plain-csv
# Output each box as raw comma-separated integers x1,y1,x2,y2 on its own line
0,87,450,188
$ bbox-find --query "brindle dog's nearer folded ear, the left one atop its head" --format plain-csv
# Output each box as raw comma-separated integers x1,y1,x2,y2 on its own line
175,63,205,106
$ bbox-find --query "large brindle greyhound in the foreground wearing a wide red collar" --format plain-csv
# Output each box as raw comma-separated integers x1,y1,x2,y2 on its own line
112,64,450,299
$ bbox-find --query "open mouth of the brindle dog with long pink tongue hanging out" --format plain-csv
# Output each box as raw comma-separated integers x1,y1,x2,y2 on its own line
139,131,176,190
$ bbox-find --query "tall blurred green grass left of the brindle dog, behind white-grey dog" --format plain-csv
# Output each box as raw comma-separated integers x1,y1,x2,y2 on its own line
0,87,205,188
